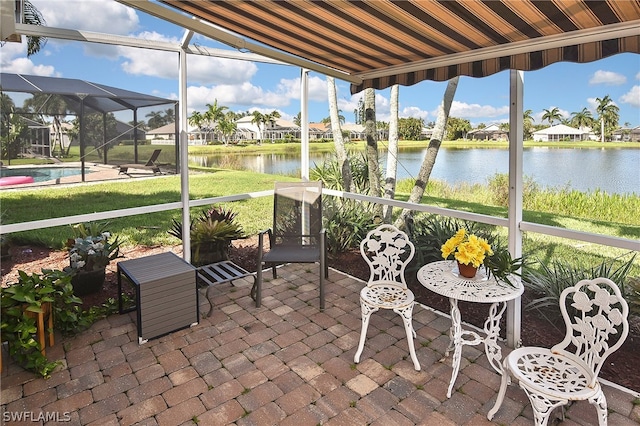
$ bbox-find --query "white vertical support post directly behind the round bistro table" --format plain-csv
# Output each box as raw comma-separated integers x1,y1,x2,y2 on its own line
507,70,524,348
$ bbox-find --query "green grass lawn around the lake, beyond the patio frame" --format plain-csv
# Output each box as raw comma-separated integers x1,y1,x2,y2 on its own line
0,141,640,275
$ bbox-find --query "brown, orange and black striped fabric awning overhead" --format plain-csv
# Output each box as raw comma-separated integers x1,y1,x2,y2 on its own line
146,0,640,93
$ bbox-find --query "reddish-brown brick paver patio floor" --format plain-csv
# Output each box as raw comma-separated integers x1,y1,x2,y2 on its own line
2,265,640,426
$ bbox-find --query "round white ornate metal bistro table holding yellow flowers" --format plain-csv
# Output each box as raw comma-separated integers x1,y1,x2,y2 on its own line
418,260,524,398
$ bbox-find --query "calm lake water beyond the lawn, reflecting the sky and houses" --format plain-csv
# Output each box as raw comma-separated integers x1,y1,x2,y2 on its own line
189,148,640,194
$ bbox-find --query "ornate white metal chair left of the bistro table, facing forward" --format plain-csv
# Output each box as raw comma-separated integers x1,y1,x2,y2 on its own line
354,225,420,370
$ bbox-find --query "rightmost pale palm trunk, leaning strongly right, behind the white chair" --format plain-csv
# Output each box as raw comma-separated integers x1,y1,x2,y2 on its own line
395,77,459,228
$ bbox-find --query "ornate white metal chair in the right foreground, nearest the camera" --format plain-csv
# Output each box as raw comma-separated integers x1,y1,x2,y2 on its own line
487,278,629,426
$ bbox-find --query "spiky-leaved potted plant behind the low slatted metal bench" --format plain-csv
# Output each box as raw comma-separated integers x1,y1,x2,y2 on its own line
168,206,245,266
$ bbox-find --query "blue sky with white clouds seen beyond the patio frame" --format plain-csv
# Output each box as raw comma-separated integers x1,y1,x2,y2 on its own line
0,0,640,127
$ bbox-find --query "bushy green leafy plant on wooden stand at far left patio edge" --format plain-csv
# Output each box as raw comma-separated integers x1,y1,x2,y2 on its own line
0,269,82,377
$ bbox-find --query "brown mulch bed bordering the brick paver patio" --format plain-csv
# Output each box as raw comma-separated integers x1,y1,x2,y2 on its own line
0,238,640,392
